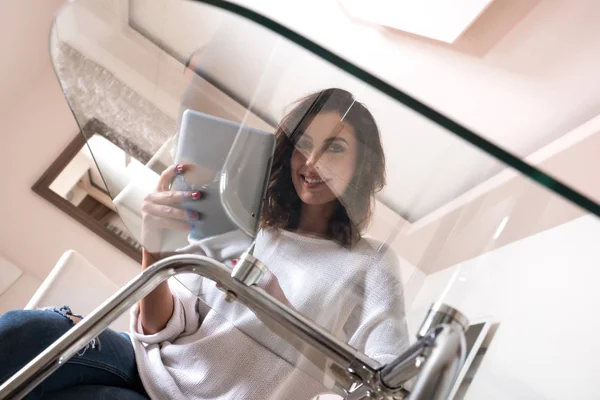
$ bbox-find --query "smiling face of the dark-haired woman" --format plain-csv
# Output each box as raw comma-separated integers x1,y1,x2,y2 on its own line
292,112,358,205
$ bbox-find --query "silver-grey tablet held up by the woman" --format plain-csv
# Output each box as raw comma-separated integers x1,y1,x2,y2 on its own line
173,110,275,240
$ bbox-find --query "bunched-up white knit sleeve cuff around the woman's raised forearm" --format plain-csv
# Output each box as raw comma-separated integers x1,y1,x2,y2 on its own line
130,278,204,344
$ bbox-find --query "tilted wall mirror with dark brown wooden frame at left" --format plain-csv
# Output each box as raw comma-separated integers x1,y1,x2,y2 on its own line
32,119,151,261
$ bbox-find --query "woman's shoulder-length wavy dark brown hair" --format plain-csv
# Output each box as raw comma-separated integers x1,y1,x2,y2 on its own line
260,88,385,248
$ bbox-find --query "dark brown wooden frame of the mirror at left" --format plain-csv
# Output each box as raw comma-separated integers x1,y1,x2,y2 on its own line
31,119,145,263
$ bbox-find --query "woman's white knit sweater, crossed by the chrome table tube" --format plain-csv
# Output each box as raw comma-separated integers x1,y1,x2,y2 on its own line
131,231,408,400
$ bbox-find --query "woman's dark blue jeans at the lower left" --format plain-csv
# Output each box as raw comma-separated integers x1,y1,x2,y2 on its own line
0,307,148,400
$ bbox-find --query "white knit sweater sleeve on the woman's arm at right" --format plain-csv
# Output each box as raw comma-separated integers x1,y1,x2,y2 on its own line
347,247,409,364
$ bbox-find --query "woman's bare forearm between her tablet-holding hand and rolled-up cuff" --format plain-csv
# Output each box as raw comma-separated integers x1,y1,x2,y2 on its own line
140,250,174,335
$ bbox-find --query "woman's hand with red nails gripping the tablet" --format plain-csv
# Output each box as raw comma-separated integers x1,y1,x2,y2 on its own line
141,164,202,254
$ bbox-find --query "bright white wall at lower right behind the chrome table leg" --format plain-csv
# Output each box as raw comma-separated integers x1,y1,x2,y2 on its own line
410,215,600,400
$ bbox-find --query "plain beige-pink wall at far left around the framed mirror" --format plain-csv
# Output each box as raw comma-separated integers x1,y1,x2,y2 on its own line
0,65,139,312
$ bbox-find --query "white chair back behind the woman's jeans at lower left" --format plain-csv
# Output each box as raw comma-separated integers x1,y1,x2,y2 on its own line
25,250,129,332
